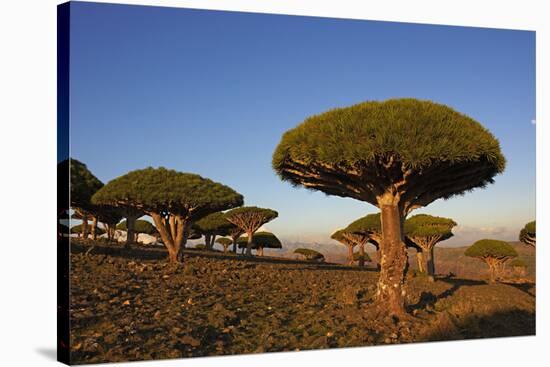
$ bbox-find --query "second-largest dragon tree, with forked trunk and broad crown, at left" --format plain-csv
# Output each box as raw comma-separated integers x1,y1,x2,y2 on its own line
92,167,243,263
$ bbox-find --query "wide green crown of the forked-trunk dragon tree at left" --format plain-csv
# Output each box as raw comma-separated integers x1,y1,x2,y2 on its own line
92,167,243,218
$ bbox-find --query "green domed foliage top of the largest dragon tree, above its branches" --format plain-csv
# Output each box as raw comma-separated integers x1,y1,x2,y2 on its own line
273,98,505,172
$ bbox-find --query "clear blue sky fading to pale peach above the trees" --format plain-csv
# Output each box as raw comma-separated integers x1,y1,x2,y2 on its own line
70,2,536,245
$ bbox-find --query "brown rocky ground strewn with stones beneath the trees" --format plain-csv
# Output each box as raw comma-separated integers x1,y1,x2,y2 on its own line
71,244,535,363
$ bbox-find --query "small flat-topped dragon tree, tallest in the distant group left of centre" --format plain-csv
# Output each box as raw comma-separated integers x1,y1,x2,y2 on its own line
225,206,279,256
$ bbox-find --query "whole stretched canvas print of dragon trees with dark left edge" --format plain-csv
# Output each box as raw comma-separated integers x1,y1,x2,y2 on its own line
57,2,536,364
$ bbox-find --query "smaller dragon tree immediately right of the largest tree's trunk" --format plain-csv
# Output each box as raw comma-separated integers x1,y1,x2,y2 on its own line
405,214,456,279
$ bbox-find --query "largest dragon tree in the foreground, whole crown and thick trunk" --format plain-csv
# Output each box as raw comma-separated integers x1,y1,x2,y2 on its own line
273,99,505,316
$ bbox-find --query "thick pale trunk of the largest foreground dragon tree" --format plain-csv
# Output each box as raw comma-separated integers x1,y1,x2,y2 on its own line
377,203,407,316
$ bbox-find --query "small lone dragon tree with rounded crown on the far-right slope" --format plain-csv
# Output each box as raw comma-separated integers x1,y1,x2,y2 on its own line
464,239,518,283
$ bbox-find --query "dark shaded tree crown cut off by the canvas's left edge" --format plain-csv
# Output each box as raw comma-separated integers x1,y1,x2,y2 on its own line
64,158,103,210
